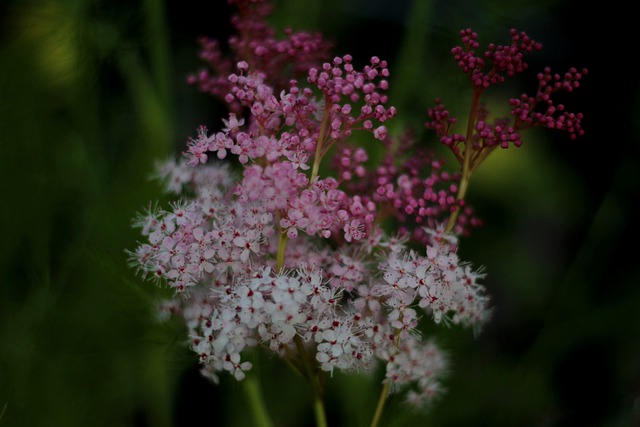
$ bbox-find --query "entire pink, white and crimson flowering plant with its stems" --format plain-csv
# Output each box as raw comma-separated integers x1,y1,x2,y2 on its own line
129,0,586,427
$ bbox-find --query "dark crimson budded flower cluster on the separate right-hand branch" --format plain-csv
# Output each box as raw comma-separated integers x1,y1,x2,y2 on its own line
425,29,587,171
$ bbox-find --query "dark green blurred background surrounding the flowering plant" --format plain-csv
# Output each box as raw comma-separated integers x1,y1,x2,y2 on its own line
0,0,640,427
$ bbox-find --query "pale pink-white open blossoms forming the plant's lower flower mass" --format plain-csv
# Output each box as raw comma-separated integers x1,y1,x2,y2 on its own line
134,150,488,402
